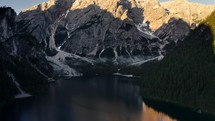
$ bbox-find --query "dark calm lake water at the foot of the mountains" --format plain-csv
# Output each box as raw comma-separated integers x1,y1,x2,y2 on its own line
3,76,215,121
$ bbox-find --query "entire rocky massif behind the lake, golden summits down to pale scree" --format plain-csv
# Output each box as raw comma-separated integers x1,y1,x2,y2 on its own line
0,0,215,76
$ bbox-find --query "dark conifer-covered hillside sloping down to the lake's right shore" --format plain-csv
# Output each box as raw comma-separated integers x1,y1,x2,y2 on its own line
141,12,215,113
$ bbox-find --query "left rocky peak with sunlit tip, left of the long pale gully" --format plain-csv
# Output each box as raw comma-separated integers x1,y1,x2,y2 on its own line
16,0,74,52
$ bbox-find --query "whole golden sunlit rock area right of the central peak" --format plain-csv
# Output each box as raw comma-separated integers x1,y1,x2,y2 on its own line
141,0,215,30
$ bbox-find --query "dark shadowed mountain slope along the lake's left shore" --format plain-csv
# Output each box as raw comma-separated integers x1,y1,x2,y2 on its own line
0,7,53,115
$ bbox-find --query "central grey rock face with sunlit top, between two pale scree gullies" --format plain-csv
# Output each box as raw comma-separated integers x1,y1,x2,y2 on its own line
56,0,159,59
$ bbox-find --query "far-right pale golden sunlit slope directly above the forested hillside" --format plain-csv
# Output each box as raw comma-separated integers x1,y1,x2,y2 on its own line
161,0,215,25
